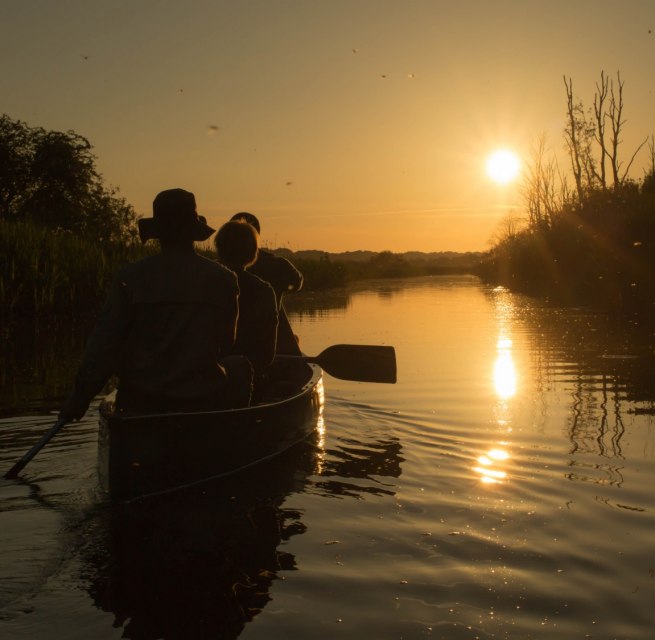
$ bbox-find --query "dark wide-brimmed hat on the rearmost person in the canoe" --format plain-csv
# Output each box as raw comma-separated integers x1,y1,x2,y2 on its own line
138,189,216,242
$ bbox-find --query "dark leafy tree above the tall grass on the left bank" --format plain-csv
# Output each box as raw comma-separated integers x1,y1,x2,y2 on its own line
0,114,136,241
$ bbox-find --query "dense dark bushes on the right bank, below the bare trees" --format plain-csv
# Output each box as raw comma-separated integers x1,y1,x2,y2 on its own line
479,175,655,315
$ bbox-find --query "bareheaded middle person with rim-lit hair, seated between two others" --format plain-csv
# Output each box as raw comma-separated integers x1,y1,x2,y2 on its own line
214,220,278,399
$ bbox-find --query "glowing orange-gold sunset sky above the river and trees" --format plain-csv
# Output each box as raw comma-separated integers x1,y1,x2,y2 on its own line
0,0,655,251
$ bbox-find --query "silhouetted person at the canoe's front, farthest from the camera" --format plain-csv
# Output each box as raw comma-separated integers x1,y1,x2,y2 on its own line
231,211,303,354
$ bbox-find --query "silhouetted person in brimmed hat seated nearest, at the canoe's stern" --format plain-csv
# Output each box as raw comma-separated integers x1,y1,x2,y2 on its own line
60,189,251,420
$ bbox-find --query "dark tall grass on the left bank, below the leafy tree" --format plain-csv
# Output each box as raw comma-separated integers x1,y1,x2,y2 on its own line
0,220,152,320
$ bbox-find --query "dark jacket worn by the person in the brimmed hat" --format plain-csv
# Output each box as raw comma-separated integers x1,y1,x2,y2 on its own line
66,249,238,406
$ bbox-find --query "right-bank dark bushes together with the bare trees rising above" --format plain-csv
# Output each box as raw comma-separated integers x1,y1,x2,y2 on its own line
478,73,655,314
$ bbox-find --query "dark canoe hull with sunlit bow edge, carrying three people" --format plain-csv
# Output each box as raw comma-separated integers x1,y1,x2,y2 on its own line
98,358,324,500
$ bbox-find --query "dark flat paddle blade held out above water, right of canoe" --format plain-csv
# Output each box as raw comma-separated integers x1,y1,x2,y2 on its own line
310,344,396,384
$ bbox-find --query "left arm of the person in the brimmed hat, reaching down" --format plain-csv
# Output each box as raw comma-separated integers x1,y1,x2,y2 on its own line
59,276,131,421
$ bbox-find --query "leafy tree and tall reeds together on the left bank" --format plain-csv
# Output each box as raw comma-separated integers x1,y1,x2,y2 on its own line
0,115,144,326
